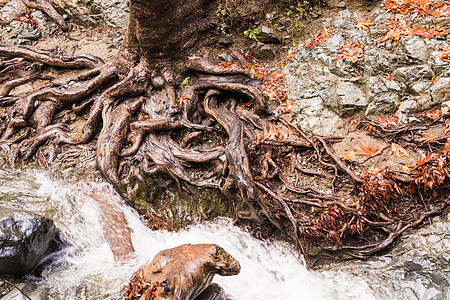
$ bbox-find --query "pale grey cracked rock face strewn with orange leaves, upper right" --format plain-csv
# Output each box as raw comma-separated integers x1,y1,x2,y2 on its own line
284,8,450,135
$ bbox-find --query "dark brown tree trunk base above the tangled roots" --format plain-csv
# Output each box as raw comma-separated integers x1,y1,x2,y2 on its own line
124,0,214,62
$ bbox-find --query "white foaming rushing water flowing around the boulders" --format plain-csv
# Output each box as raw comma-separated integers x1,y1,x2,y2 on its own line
0,171,445,300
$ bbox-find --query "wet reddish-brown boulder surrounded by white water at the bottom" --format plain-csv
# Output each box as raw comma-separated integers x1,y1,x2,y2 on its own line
127,244,241,300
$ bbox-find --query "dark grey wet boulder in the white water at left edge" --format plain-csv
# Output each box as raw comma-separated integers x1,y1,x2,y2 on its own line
0,207,60,276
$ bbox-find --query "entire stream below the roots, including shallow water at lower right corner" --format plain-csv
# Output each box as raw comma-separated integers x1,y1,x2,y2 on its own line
0,170,450,300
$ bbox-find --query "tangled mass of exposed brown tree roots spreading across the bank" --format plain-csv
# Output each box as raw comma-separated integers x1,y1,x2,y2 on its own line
0,45,450,268
